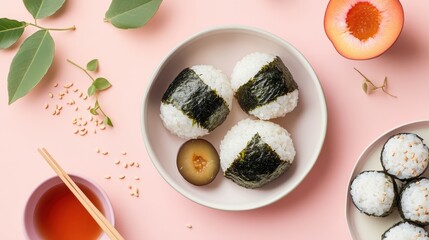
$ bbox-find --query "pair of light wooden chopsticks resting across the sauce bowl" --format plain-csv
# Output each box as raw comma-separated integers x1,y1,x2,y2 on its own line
37,148,124,240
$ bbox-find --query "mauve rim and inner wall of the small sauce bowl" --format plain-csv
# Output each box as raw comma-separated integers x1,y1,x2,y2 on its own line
22,174,115,240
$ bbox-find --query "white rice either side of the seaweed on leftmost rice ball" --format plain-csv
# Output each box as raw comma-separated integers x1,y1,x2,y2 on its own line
160,65,233,139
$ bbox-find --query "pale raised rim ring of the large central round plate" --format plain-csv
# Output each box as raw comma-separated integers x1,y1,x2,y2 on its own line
140,25,328,211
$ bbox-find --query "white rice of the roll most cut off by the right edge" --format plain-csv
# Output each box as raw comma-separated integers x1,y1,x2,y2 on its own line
400,178,429,224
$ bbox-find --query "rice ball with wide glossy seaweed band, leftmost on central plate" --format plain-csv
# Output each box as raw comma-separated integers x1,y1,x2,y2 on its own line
160,65,233,139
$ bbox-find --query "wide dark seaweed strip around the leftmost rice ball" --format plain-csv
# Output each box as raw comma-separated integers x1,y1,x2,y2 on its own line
162,68,229,131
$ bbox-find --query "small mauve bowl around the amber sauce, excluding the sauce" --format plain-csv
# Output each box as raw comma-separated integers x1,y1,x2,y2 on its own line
24,175,115,240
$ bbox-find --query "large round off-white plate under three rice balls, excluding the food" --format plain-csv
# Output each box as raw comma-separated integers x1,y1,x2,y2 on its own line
142,26,327,210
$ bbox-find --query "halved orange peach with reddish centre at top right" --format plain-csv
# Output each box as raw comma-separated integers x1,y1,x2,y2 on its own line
324,0,404,59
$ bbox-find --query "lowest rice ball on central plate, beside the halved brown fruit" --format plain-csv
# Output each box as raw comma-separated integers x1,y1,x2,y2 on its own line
219,119,295,188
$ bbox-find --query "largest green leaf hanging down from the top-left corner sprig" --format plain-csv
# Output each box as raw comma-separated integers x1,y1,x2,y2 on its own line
7,30,55,104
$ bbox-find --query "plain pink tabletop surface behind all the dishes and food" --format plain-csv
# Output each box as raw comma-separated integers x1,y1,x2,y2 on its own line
0,0,429,240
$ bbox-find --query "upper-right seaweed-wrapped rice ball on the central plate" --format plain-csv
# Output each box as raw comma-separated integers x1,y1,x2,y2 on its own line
231,52,298,120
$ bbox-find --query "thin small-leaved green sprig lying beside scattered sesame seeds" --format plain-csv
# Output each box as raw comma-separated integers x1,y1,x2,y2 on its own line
67,59,113,127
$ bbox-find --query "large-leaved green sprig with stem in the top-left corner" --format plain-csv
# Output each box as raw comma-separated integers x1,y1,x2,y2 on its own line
0,0,76,105
